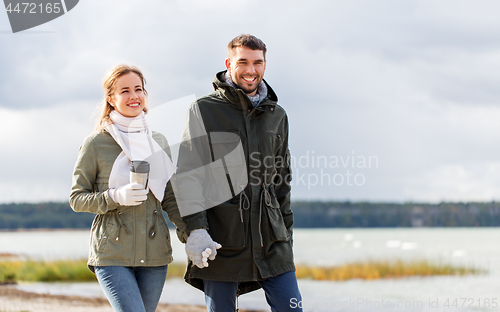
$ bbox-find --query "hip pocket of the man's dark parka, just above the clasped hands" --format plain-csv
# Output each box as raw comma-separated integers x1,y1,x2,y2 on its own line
207,199,246,250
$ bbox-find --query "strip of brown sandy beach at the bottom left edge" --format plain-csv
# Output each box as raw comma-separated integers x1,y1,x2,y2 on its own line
0,285,262,312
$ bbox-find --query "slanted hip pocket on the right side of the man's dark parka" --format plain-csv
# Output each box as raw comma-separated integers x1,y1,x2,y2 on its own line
263,185,290,242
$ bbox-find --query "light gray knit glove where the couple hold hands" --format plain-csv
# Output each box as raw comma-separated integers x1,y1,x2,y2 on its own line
186,229,222,269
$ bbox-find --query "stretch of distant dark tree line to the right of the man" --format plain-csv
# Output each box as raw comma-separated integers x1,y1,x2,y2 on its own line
292,201,500,228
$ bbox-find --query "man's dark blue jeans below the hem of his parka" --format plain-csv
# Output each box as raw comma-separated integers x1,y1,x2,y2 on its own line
203,271,302,312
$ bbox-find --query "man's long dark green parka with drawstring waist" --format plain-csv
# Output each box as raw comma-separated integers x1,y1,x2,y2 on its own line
179,71,295,294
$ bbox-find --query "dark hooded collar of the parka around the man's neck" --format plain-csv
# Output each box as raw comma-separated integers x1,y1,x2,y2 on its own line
212,70,278,114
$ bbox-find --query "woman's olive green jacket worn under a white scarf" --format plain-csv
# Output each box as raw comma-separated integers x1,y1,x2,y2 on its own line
70,130,187,271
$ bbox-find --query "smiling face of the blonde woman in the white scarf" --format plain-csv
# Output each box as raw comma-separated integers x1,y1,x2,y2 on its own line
108,72,146,117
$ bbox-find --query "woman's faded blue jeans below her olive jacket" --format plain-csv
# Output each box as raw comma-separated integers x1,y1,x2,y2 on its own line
95,265,167,312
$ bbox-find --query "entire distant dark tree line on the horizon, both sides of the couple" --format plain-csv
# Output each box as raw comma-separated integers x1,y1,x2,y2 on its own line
0,201,500,230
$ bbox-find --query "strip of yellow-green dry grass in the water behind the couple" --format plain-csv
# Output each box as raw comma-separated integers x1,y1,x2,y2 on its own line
0,260,486,284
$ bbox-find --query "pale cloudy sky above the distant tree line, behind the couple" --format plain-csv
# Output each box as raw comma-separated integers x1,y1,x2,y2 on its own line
0,0,500,203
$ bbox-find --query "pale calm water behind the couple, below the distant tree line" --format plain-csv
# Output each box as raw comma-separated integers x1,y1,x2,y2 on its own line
0,228,500,312
